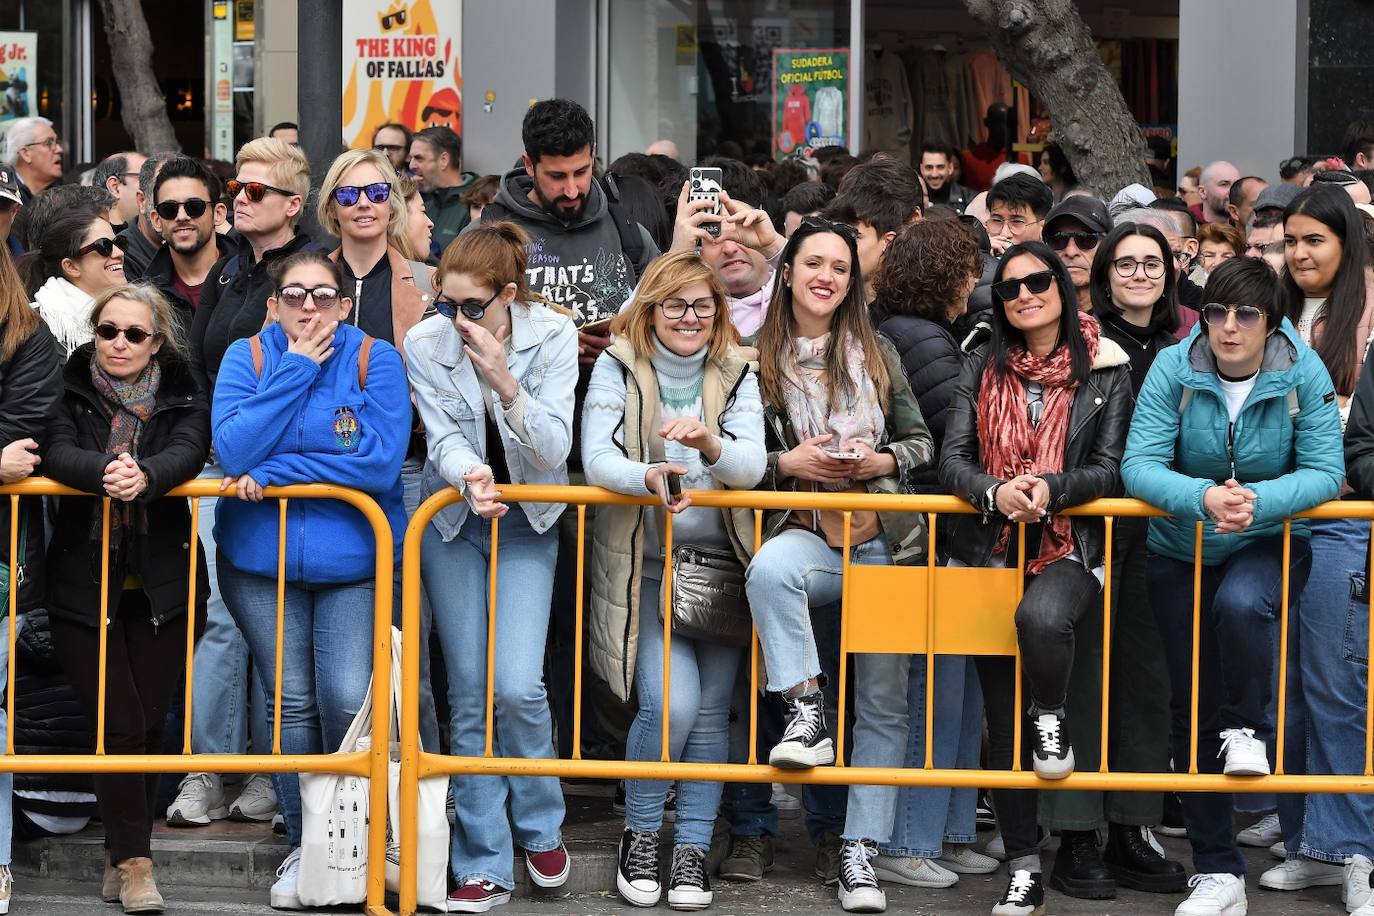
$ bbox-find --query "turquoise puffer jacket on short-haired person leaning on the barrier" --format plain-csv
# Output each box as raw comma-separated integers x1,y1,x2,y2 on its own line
1121,319,1345,566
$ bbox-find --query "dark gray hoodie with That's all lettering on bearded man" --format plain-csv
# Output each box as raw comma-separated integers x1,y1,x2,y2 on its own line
482,169,660,327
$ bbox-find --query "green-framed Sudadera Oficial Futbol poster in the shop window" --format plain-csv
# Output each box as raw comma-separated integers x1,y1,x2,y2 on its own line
772,48,849,159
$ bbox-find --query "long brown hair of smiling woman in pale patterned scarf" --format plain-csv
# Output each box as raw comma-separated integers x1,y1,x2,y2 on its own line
758,220,892,413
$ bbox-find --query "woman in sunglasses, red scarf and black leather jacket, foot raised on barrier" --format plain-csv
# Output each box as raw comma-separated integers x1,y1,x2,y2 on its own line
940,242,1131,916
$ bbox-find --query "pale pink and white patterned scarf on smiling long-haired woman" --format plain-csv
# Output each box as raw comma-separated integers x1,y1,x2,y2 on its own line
785,334,885,490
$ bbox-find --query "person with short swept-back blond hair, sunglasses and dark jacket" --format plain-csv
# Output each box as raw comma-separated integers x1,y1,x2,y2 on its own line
190,137,323,393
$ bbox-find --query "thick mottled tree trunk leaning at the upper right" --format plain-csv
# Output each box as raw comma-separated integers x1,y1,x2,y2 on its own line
963,0,1150,199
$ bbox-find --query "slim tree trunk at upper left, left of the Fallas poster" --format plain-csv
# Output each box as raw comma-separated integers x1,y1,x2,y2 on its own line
100,0,181,152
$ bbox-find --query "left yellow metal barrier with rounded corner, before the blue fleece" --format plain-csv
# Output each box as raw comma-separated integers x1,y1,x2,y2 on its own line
0,478,398,916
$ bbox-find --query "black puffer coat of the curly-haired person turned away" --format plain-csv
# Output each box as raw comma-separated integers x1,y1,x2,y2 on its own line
878,314,963,493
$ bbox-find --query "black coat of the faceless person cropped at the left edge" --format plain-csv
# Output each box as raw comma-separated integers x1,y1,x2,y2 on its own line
0,321,62,618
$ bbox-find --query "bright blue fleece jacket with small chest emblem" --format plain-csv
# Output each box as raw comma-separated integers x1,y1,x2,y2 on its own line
212,324,411,585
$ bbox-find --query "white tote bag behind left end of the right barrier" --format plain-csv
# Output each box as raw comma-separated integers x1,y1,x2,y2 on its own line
386,628,449,912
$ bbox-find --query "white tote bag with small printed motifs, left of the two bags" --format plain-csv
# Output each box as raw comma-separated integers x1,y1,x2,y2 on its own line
297,689,372,906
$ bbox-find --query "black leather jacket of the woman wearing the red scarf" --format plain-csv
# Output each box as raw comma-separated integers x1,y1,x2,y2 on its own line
940,346,1132,570
